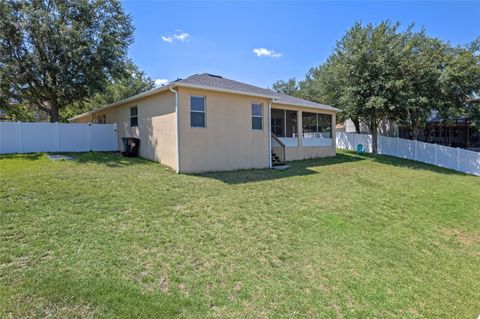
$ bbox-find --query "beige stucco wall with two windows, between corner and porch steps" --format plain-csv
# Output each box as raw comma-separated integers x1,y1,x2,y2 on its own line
178,87,270,172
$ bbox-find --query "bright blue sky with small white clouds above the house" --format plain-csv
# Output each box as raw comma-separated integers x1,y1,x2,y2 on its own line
122,0,480,87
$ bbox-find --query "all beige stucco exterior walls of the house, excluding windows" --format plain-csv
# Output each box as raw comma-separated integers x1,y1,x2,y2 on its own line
74,87,335,173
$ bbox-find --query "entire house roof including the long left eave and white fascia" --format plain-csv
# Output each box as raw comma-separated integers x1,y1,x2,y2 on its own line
70,73,340,120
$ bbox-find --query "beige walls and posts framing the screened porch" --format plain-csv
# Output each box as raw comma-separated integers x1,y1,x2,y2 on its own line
272,103,336,161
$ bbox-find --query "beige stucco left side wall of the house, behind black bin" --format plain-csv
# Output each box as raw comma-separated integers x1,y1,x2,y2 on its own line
74,91,177,169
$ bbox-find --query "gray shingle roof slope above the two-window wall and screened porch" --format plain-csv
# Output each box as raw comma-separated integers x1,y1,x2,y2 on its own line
175,73,338,111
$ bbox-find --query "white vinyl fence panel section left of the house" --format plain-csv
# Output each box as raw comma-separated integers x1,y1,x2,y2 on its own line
0,122,118,154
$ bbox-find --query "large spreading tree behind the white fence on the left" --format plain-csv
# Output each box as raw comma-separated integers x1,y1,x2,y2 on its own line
0,0,133,122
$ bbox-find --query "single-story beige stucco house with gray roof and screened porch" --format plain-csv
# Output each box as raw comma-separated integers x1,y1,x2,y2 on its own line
71,73,339,172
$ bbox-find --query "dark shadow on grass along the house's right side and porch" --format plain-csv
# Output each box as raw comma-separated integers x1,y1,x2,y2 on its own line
197,153,365,184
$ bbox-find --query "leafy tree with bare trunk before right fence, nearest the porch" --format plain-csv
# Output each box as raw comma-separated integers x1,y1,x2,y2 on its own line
318,21,412,153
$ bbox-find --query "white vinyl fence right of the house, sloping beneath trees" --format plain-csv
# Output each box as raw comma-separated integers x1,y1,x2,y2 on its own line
336,132,480,176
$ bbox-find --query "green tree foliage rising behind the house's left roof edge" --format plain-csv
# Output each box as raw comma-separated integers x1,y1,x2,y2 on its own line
60,61,155,120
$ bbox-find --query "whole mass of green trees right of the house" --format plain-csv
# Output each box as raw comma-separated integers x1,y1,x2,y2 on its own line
277,21,480,152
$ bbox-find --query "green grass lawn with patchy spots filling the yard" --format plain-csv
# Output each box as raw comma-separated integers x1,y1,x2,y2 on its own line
0,152,480,318
